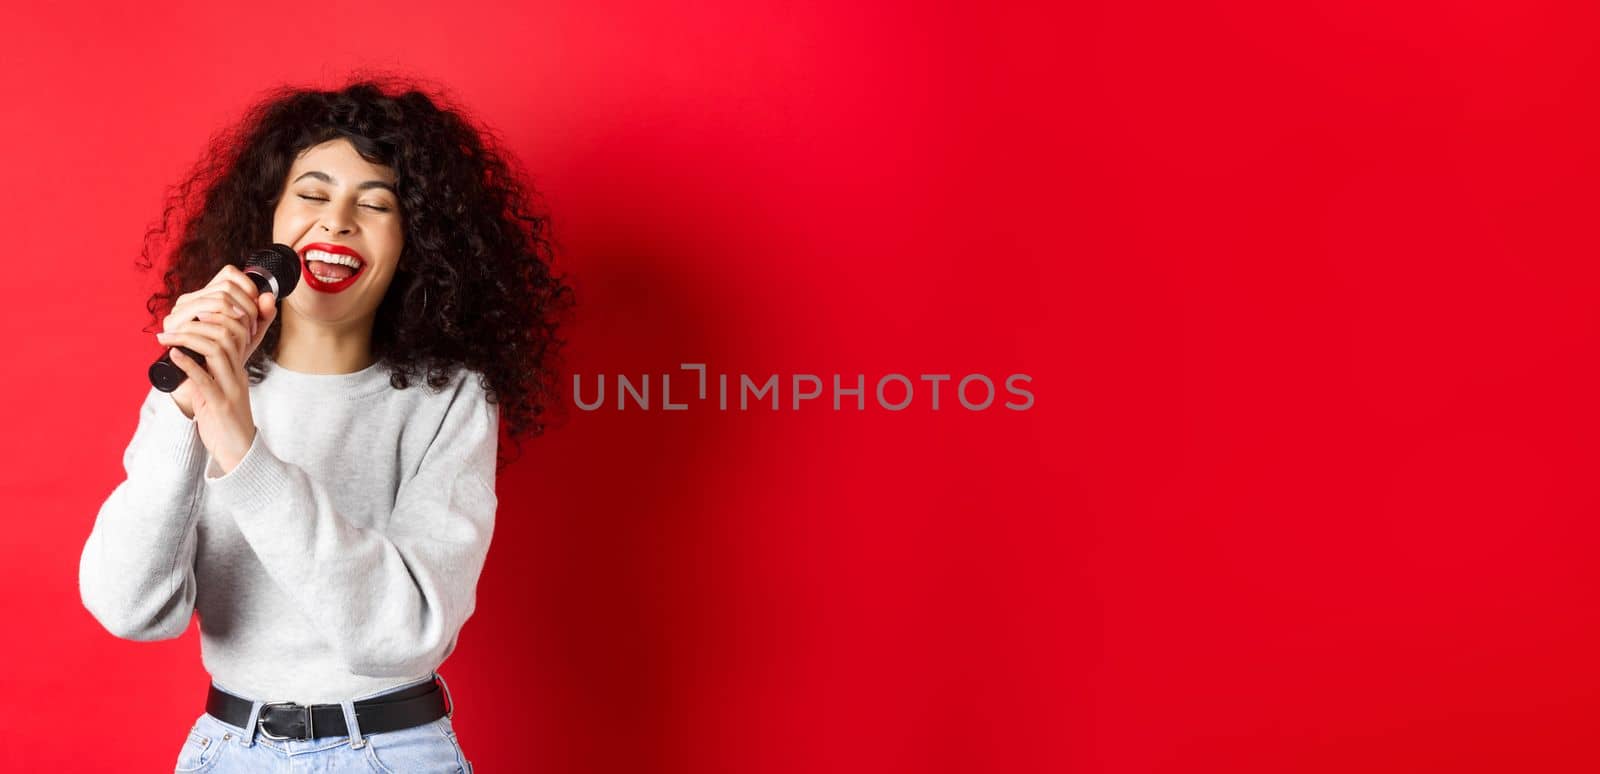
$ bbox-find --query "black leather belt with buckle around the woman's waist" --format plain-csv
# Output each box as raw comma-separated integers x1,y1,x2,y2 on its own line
205,680,453,740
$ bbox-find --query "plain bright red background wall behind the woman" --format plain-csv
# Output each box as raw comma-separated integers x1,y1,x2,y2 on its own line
0,0,1600,774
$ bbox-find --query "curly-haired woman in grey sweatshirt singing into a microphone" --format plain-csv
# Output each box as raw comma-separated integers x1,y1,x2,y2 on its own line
78,82,571,772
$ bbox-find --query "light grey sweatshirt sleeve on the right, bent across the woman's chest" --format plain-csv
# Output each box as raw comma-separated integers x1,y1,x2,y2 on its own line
205,373,499,676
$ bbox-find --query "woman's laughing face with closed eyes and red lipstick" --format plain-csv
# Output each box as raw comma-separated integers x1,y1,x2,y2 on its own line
272,138,405,325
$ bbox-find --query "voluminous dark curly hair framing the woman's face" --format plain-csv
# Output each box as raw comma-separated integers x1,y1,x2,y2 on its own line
139,75,573,465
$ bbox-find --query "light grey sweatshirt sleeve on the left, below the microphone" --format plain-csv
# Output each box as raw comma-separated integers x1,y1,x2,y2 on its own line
78,387,206,640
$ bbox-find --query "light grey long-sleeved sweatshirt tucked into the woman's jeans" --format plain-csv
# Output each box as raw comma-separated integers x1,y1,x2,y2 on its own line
78,358,499,704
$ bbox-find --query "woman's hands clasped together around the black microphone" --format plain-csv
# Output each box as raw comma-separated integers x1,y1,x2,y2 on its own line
155,265,277,473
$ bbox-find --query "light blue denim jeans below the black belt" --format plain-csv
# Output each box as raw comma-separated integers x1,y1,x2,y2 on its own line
173,672,472,774
